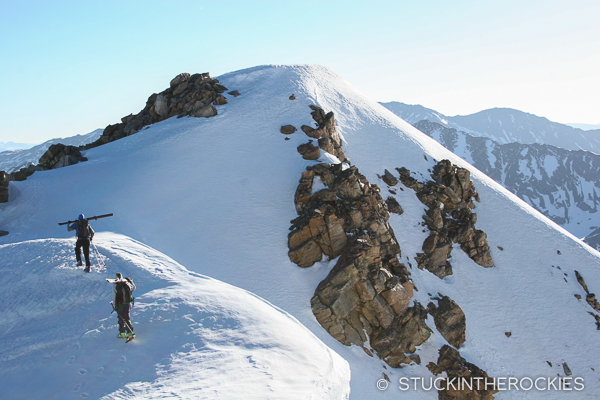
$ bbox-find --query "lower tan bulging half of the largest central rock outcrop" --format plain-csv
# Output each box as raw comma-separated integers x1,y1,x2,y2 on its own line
311,240,420,354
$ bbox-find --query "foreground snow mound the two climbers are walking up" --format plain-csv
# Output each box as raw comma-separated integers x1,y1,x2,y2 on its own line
0,233,350,399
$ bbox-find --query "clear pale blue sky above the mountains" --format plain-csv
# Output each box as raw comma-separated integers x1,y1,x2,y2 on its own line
0,0,600,142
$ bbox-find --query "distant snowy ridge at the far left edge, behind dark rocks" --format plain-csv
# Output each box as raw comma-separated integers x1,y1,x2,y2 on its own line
0,129,104,173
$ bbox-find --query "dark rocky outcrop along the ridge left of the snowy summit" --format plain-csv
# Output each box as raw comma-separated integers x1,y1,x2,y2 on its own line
85,73,230,148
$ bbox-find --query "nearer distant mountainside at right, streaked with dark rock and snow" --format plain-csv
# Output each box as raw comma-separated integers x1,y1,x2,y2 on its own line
415,121,600,246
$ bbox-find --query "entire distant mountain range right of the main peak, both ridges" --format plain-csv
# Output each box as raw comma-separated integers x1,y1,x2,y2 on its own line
383,102,600,249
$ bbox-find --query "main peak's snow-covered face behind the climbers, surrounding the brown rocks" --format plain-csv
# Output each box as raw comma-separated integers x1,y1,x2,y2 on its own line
0,66,600,399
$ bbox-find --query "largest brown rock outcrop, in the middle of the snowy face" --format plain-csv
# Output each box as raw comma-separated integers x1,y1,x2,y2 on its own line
288,163,431,367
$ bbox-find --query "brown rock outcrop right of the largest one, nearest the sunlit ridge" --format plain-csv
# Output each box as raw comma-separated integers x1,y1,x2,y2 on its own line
396,160,494,278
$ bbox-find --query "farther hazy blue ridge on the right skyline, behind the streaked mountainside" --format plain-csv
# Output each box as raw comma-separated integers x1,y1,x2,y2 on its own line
381,102,600,154
